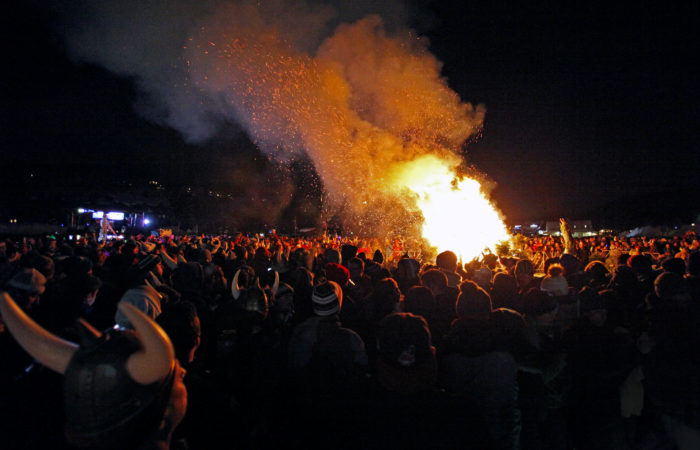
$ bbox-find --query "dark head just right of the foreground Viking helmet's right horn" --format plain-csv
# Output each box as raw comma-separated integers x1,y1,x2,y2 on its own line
156,301,202,366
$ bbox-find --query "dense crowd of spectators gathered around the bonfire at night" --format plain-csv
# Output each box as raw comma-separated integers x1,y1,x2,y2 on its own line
0,221,700,449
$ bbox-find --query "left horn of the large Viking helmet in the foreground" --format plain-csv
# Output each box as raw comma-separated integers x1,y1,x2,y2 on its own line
0,292,78,374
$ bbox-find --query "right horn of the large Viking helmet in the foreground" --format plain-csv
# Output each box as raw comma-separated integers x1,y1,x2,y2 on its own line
119,302,175,384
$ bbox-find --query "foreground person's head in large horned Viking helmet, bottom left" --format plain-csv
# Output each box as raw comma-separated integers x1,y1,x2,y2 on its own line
0,293,187,448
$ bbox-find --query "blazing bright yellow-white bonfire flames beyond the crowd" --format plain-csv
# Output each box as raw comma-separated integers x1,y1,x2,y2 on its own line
393,155,510,261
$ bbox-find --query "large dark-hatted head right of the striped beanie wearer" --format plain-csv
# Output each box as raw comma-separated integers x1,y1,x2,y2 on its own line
377,313,437,393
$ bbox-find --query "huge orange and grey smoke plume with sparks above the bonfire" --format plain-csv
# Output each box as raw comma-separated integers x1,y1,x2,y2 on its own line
56,0,484,236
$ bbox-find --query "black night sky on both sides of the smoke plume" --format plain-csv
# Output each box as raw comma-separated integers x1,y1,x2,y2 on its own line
0,1,700,223
